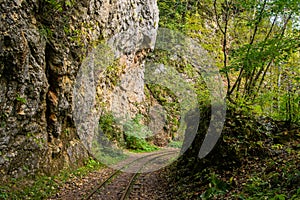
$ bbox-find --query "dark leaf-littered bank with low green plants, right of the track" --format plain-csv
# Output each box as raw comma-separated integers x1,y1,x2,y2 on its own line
168,119,300,200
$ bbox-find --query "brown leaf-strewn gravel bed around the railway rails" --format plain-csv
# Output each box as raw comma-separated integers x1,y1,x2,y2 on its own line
49,150,174,200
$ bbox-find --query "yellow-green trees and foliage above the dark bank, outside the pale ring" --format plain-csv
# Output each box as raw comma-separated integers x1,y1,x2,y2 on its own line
158,0,300,122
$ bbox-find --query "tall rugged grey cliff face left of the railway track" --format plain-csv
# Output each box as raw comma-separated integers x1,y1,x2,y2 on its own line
0,0,158,179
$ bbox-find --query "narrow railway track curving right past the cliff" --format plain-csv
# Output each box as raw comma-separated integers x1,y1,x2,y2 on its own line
84,150,178,200
